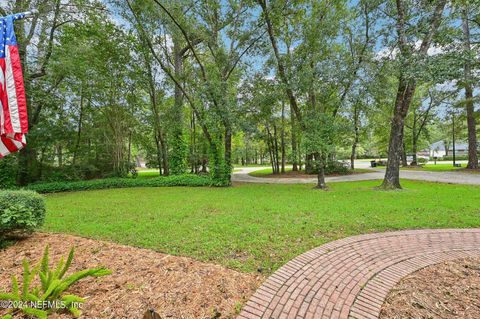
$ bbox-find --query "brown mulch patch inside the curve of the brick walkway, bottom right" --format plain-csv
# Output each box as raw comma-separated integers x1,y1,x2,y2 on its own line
380,258,480,319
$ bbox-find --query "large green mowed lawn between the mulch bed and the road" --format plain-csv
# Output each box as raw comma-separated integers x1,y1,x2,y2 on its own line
43,181,480,274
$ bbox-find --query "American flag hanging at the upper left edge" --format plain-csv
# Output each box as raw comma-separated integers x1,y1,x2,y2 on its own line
0,14,28,158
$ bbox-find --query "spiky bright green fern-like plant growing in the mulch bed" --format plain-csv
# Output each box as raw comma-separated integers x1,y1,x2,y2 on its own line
0,246,111,319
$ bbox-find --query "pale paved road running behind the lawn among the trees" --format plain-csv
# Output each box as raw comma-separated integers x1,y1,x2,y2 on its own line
232,163,480,185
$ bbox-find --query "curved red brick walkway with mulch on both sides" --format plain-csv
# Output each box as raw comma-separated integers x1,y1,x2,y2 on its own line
238,228,480,319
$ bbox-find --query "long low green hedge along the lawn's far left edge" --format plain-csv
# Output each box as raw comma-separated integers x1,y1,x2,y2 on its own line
26,174,216,194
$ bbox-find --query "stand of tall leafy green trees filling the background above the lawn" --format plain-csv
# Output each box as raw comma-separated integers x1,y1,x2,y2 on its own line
0,0,480,188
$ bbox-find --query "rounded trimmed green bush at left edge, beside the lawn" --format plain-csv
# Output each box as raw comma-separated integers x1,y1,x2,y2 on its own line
0,190,45,241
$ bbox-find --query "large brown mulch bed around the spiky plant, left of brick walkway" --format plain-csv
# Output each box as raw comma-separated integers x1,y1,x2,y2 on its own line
0,234,264,319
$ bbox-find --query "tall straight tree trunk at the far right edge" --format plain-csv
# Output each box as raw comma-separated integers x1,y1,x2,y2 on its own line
462,4,478,169
